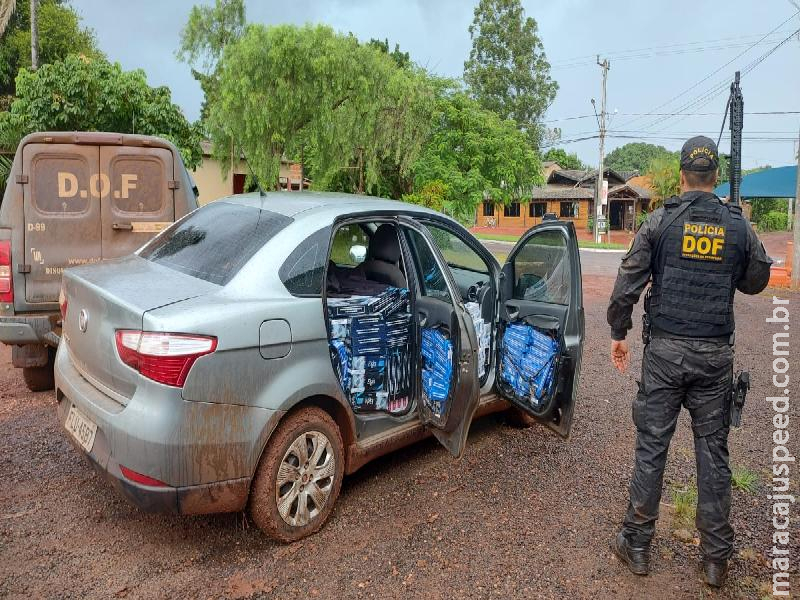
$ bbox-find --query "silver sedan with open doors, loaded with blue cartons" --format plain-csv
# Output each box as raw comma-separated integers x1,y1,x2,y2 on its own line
55,193,584,541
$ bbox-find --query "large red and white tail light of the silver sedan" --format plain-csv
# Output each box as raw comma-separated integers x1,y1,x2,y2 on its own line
116,329,217,387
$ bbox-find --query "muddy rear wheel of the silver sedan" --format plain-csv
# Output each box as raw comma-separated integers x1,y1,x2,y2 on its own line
249,407,344,542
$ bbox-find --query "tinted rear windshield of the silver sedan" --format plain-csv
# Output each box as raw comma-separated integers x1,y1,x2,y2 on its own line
139,202,293,285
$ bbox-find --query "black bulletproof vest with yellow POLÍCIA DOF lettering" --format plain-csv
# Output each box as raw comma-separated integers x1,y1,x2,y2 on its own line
649,192,747,337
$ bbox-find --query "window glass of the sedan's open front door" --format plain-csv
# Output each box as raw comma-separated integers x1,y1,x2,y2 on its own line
514,231,570,304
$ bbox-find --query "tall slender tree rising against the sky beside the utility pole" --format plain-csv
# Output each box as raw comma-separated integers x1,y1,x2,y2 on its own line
464,0,558,147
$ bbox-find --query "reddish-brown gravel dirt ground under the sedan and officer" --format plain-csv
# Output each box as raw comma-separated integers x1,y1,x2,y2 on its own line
0,254,800,600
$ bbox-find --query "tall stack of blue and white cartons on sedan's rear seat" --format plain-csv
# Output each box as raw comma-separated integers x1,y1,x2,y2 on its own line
328,287,412,412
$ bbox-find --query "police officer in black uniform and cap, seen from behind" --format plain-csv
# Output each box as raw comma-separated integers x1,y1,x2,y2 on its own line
607,136,771,587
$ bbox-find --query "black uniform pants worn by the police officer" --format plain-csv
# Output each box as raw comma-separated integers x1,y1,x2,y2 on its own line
623,338,734,561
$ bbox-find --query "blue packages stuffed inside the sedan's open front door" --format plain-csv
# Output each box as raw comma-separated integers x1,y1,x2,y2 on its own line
500,323,559,406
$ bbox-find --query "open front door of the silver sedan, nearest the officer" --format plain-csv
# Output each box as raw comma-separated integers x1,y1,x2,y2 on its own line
496,220,584,437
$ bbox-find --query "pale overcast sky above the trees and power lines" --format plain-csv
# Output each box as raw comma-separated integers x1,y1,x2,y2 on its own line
71,0,800,168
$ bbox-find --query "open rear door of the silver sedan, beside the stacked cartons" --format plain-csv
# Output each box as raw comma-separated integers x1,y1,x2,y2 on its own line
400,217,480,457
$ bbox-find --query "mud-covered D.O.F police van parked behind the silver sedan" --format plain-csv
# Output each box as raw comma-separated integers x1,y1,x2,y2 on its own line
0,132,197,390
